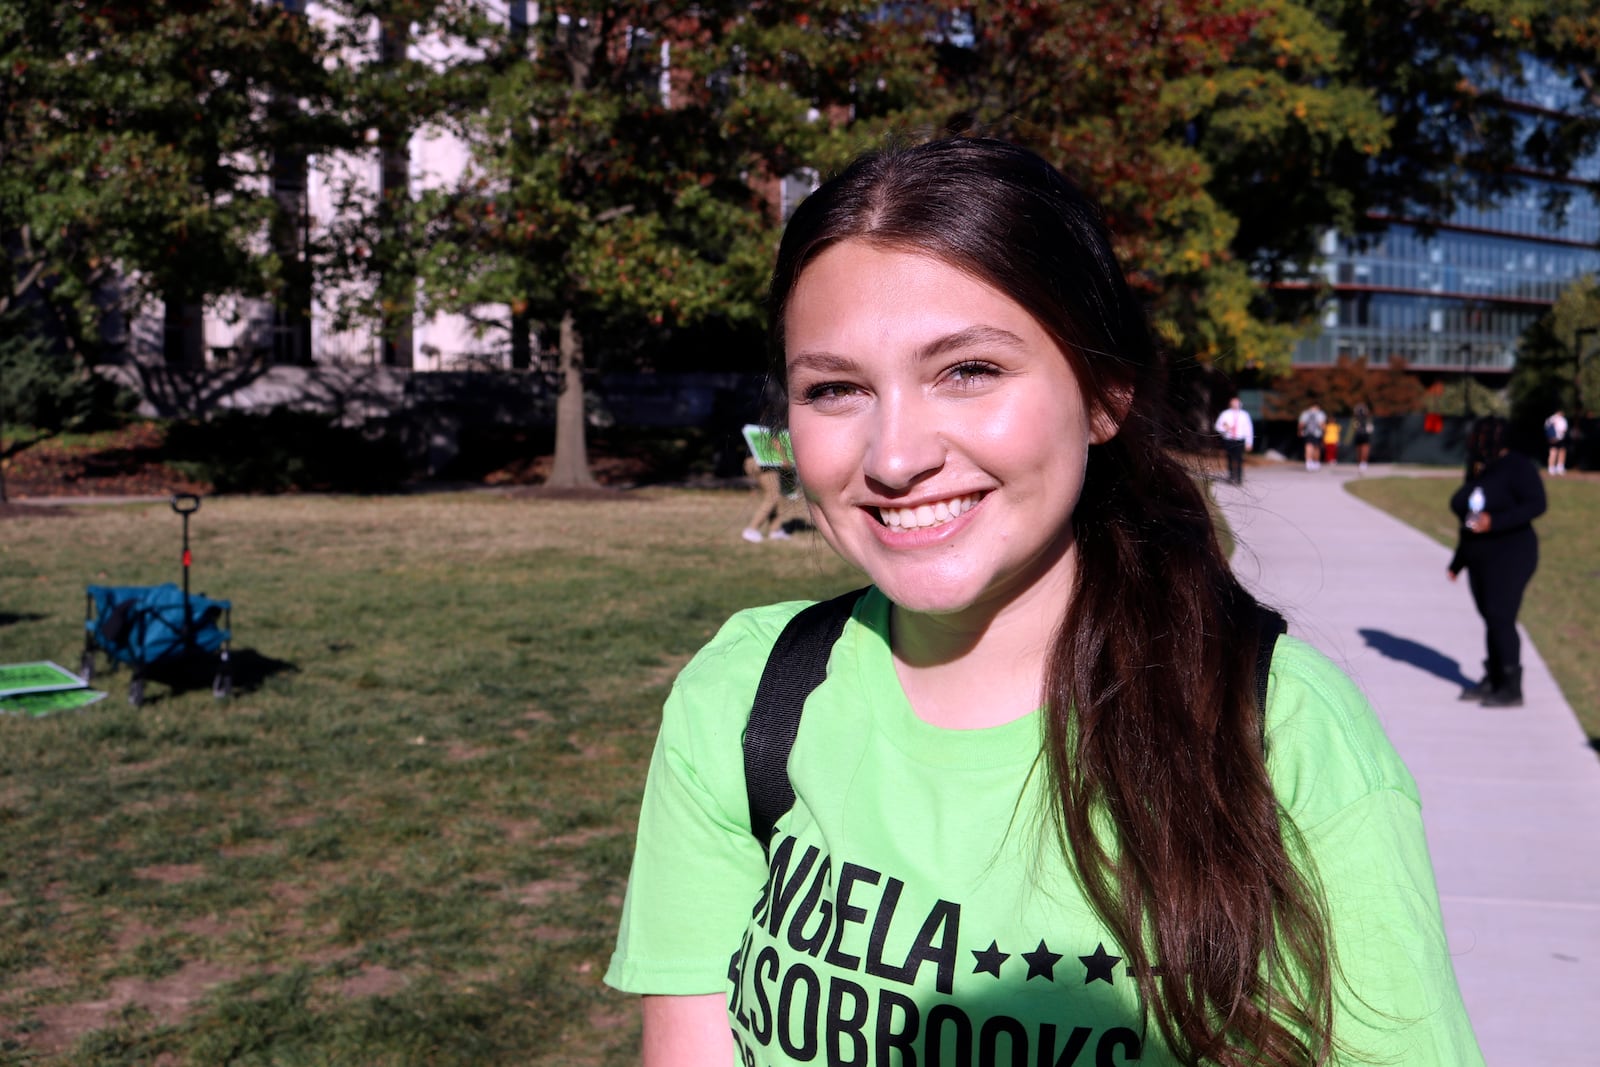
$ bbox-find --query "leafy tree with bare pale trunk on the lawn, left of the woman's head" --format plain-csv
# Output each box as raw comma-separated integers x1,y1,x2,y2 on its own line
413,0,926,486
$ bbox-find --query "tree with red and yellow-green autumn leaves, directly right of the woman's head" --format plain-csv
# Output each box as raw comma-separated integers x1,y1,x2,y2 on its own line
949,0,1387,377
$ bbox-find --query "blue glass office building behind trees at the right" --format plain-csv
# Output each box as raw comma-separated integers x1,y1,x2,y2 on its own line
1294,60,1600,376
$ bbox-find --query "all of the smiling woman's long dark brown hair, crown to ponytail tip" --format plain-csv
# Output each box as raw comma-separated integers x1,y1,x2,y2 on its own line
770,138,1333,1067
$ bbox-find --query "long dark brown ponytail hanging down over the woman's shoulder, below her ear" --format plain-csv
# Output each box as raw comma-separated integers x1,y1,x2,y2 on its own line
1046,398,1333,1067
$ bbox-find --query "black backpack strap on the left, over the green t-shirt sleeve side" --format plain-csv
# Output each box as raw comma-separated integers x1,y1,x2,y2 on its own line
744,589,867,848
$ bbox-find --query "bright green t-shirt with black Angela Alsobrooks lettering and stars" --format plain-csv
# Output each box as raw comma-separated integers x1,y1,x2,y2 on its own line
606,592,1482,1067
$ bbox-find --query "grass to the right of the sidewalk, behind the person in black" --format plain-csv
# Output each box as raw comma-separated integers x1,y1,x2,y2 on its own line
1346,477,1600,739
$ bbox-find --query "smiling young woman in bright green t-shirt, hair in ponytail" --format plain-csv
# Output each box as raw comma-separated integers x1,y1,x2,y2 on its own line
606,139,1482,1067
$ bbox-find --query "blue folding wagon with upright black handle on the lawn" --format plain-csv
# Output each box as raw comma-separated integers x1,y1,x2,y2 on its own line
82,493,234,707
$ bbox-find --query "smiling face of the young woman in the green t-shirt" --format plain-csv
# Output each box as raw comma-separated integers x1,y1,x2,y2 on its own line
784,240,1104,633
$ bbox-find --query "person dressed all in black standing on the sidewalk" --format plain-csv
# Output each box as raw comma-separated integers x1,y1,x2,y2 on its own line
1450,416,1544,707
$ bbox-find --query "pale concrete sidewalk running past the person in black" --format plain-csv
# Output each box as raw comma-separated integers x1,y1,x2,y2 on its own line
1216,464,1600,1067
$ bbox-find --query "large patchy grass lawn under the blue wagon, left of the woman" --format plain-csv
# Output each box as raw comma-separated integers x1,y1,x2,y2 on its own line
0,490,854,1067
